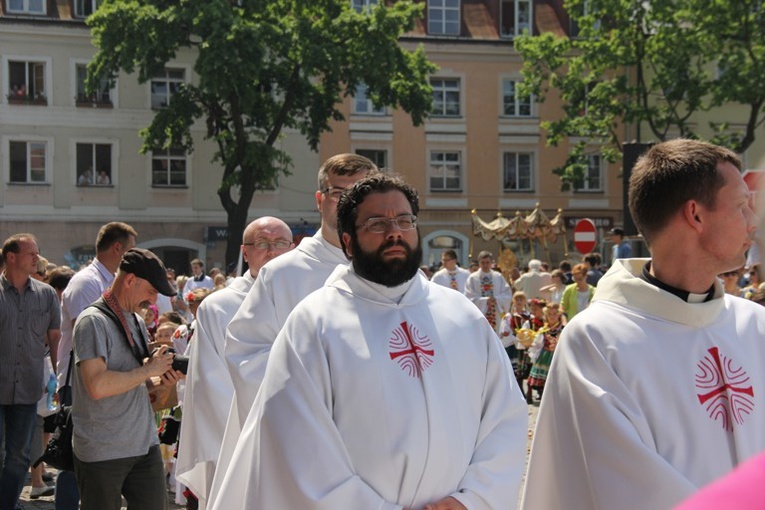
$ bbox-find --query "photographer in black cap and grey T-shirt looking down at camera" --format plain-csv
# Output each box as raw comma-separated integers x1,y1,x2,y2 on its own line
72,248,182,510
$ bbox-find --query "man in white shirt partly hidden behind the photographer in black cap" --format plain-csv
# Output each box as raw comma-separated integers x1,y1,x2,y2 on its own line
56,221,138,510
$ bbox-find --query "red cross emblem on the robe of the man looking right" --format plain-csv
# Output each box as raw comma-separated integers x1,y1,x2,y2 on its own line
696,347,754,431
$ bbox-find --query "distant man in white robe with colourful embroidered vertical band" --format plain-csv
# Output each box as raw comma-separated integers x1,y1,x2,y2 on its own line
465,250,513,331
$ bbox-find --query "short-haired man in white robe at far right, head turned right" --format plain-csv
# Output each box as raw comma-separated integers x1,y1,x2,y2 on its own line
522,140,765,510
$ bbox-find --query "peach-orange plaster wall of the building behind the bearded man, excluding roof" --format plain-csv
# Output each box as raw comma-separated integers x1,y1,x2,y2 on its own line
319,40,623,265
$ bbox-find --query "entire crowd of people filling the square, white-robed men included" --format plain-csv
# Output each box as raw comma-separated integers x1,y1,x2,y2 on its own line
0,140,765,510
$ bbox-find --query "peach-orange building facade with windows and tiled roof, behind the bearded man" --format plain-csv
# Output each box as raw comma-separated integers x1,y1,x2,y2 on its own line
320,0,623,265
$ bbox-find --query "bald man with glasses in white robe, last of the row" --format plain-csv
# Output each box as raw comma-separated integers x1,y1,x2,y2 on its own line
175,216,294,510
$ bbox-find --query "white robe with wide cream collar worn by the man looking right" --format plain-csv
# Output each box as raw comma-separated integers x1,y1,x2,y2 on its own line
522,259,765,510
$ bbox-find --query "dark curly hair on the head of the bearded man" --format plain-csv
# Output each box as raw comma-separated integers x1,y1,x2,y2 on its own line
337,173,420,256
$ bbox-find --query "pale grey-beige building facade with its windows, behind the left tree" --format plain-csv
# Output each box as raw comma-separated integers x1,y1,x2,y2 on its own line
0,0,319,273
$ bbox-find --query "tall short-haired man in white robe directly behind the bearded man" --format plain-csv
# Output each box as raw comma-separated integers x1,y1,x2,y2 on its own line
209,154,378,501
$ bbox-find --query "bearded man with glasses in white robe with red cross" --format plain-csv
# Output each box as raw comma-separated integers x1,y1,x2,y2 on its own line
214,174,527,510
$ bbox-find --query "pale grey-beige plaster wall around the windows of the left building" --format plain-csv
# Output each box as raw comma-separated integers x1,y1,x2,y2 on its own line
0,19,319,272
